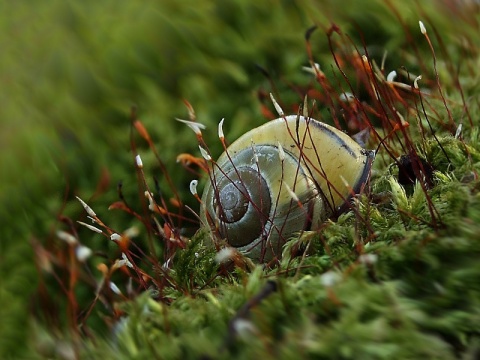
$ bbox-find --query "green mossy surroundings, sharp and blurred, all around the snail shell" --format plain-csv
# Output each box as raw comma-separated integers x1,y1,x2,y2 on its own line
0,1,480,359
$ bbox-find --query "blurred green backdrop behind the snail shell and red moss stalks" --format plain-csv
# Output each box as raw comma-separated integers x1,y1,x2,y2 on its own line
0,0,478,356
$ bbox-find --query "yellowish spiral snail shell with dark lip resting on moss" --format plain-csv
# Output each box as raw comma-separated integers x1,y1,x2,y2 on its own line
200,115,374,262
